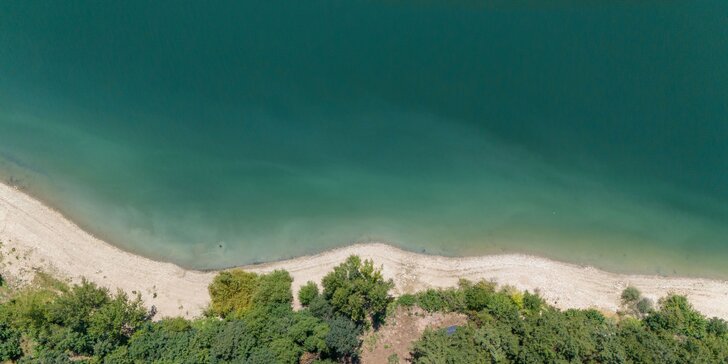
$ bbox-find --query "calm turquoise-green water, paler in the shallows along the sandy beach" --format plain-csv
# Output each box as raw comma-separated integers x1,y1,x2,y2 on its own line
0,1,728,277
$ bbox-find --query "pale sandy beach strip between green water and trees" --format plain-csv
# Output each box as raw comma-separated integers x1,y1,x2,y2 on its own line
0,184,728,319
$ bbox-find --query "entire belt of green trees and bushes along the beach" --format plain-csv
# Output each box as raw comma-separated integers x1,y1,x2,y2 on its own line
0,257,728,364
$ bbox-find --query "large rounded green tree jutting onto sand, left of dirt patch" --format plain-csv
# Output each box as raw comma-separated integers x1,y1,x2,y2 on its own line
322,255,394,324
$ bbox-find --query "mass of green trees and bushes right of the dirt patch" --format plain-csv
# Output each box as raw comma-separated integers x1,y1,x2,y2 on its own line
411,282,728,363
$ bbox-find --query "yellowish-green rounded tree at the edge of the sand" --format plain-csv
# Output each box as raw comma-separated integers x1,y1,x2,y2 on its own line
208,269,258,318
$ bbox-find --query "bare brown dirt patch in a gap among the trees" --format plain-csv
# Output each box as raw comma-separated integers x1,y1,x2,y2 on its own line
361,307,467,364
